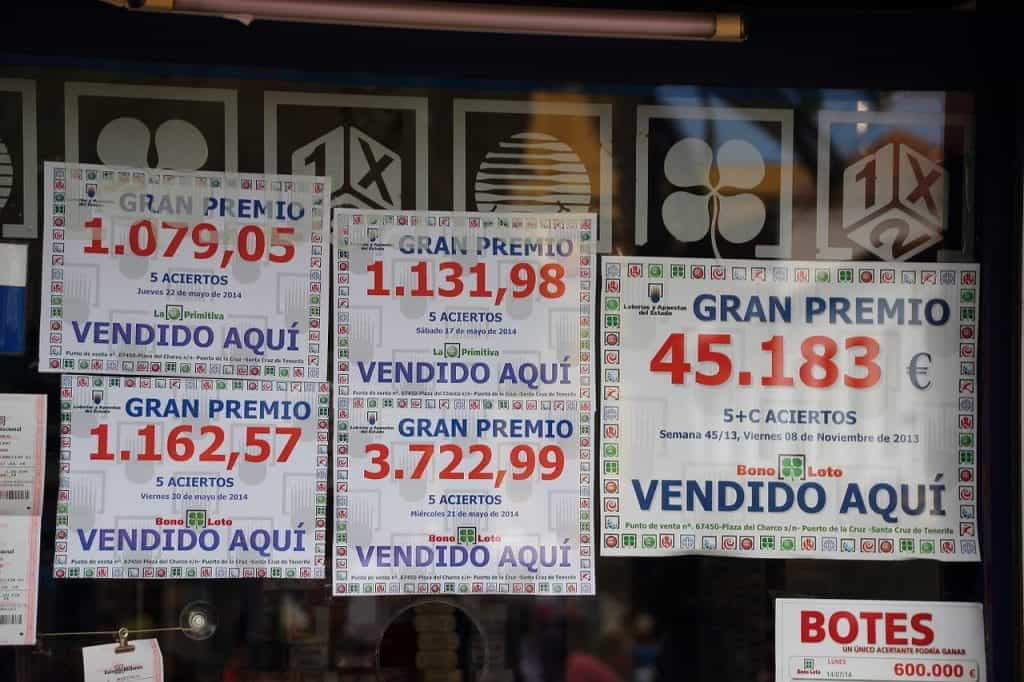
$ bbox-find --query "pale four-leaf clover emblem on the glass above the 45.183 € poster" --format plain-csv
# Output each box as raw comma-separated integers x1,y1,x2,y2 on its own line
662,137,767,257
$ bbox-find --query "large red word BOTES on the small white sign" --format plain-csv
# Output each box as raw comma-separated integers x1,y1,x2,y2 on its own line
800,609,935,646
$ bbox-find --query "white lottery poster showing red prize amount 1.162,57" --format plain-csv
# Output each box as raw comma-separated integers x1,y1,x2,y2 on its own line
53,375,330,579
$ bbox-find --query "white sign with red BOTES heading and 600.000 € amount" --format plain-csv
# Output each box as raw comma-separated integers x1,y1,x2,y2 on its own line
775,599,986,682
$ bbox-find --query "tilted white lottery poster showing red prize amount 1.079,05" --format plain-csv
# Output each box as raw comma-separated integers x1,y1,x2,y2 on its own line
39,163,331,381
